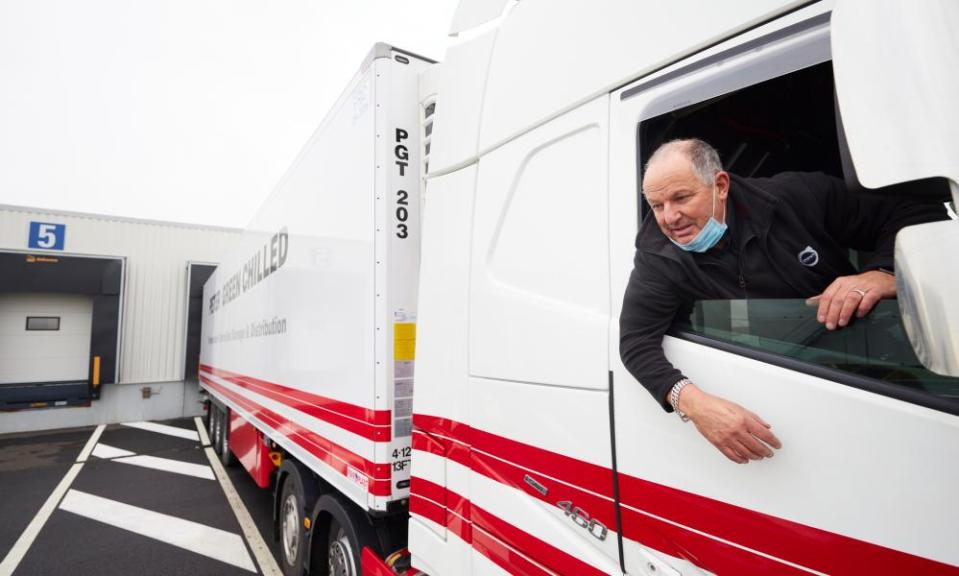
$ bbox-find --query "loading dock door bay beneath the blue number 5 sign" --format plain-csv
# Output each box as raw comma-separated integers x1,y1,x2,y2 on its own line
0,252,123,410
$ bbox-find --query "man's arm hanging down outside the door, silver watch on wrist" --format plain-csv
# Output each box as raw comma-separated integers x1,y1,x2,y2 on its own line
619,251,782,464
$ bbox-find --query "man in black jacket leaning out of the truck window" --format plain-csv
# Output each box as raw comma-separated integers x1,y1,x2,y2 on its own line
620,139,947,464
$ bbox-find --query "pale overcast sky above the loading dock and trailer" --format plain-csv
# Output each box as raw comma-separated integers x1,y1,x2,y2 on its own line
0,0,456,226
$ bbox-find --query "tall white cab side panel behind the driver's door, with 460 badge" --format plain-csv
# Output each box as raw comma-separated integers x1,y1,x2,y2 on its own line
468,95,620,575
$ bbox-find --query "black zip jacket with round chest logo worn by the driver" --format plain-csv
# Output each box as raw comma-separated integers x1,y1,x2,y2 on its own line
619,172,947,411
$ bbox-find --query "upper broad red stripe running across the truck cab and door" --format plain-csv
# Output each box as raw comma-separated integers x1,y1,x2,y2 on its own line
413,414,959,576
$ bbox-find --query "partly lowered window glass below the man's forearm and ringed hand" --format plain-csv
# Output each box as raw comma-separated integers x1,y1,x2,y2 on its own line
674,299,959,401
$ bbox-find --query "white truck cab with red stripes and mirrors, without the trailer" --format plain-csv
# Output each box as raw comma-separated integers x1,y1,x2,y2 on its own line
410,1,959,574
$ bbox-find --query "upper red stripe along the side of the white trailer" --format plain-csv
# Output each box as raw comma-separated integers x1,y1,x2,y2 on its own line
200,364,392,434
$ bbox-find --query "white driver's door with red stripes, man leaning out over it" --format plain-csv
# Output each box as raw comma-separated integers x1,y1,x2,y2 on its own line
609,4,959,575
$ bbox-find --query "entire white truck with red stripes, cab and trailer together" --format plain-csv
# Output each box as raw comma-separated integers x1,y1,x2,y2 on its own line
200,0,959,576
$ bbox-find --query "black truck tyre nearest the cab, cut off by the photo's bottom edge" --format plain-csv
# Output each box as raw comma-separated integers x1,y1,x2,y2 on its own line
311,494,381,576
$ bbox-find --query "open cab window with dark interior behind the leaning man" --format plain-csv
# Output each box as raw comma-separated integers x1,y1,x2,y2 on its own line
637,61,959,413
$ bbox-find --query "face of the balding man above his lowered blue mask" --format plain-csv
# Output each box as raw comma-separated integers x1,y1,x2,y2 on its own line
643,152,729,244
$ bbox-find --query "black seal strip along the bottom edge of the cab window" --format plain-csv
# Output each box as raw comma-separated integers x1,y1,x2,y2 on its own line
667,327,959,416
